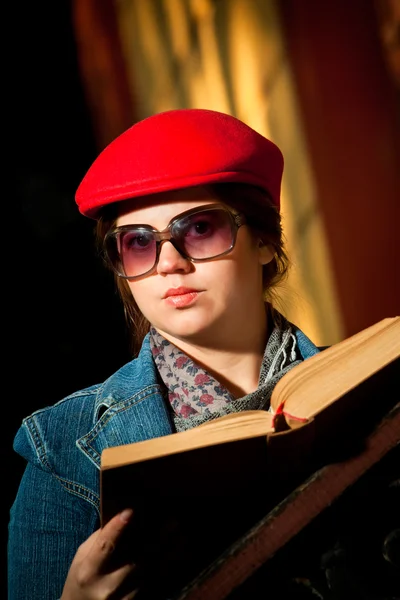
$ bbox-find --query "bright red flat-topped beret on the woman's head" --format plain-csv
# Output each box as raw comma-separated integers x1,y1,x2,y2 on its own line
75,108,283,219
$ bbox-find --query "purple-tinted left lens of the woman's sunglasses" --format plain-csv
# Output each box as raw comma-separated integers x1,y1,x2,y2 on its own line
117,229,157,277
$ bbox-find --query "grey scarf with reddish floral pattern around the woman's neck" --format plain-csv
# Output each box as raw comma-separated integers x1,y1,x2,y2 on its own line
150,311,302,431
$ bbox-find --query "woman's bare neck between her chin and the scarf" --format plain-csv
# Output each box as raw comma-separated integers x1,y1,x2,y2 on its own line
158,310,269,398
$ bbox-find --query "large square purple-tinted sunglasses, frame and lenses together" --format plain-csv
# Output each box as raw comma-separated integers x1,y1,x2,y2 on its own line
104,204,246,280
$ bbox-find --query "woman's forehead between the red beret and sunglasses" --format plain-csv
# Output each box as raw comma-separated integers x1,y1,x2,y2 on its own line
117,187,219,229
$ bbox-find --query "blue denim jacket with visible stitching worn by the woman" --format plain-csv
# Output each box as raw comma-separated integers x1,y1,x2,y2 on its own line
8,329,318,600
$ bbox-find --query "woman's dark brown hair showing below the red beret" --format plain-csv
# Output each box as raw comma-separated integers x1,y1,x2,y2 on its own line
96,183,290,355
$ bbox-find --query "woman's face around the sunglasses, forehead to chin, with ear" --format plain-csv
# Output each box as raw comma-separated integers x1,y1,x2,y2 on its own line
117,187,273,345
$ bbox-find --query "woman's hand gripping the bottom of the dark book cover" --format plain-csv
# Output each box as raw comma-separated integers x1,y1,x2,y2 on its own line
60,510,137,600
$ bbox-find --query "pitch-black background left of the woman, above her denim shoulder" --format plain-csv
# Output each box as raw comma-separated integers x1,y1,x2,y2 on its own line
2,0,129,588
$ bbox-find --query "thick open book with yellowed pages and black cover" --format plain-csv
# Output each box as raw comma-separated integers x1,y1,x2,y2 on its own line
100,317,400,598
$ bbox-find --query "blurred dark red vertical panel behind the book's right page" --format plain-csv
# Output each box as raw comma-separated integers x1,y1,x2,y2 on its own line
278,0,400,335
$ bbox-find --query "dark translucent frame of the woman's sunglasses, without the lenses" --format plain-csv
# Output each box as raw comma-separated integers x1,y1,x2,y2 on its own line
104,204,246,281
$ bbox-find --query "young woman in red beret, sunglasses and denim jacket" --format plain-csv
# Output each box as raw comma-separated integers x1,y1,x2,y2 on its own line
8,109,318,600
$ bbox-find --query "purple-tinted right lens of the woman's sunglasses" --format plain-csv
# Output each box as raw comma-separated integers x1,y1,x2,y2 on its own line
171,209,235,260
